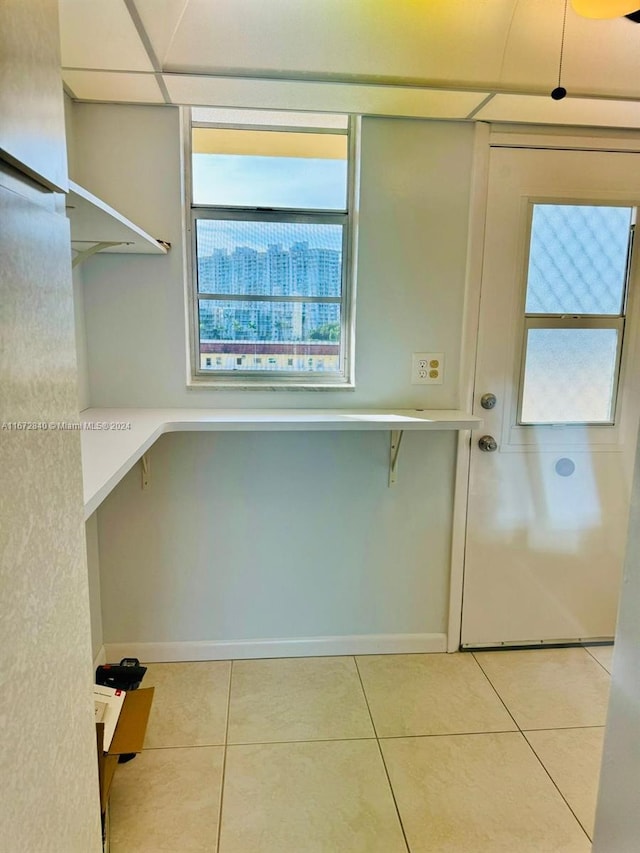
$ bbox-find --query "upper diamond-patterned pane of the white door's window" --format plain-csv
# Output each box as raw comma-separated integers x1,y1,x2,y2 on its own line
525,204,632,315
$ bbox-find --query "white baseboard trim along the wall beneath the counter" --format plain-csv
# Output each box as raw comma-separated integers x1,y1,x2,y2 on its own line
104,634,447,663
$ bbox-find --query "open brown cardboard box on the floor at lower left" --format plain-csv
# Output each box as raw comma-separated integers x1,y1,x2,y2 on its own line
96,687,154,815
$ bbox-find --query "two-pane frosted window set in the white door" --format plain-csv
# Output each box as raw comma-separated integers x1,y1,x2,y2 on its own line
519,204,635,424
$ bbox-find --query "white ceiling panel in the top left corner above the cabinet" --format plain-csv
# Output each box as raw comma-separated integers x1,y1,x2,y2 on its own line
59,0,153,71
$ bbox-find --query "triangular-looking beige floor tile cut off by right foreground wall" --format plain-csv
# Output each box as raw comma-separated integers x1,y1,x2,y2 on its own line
525,728,604,837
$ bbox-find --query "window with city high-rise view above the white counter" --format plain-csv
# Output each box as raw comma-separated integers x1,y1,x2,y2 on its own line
186,109,353,388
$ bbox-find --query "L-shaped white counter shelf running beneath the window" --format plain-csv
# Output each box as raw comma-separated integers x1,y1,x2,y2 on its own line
80,409,482,518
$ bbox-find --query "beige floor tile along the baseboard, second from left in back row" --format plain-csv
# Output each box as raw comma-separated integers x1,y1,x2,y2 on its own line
228,657,374,743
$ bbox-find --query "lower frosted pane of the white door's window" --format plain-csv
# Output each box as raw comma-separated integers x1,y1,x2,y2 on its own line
521,329,618,424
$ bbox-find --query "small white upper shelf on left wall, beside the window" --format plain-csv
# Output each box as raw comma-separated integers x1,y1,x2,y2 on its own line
66,181,169,266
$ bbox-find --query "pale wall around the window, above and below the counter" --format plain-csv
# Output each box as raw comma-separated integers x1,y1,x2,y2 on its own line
72,104,473,644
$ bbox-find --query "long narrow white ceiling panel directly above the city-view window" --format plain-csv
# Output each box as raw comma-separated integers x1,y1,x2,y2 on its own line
164,74,487,119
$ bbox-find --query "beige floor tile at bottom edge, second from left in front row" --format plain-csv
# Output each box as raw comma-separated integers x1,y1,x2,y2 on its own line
220,740,407,853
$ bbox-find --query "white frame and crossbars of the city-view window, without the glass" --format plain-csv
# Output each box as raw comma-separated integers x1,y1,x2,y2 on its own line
182,108,360,391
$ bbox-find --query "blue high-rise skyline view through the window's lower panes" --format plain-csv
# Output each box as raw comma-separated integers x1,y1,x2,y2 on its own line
197,225,342,362
